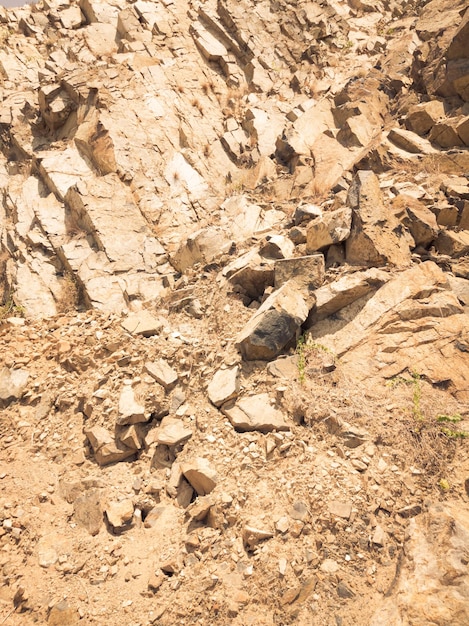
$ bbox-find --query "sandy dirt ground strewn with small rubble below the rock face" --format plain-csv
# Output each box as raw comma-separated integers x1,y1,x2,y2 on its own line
0,279,469,626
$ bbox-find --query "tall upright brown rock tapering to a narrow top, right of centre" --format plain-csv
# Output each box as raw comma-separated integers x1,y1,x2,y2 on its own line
345,170,411,267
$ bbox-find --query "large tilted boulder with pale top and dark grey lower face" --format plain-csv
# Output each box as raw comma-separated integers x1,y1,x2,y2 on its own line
236,281,314,361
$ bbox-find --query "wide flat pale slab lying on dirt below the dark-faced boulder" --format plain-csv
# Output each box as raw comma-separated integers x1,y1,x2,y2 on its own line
222,393,290,433
